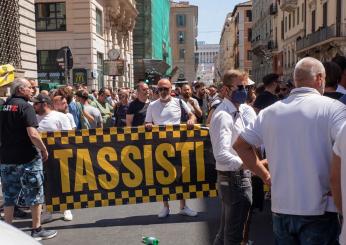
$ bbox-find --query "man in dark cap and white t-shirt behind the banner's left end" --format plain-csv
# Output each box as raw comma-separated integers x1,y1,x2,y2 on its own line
32,94,73,223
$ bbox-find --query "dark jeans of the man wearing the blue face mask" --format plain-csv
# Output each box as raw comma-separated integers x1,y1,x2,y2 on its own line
214,171,252,245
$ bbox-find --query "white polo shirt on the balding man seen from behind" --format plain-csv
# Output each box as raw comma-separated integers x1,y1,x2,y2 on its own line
241,87,346,215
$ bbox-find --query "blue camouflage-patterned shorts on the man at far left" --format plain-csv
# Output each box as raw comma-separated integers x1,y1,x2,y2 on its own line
0,158,44,207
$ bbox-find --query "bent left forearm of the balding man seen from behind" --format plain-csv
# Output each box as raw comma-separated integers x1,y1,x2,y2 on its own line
233,136,270,185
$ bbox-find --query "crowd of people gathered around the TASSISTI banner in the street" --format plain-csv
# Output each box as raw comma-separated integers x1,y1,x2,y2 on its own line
0,56,346,245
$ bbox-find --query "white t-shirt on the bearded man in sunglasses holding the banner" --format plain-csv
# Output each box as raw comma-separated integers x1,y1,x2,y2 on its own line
145,97,191,125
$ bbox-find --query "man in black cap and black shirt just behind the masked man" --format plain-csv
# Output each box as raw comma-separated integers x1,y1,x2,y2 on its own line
253,73,279,113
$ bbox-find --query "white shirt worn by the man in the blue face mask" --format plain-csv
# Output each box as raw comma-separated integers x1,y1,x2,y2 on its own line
209,98,256,171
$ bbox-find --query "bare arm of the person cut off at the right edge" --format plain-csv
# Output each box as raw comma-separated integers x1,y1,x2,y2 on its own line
330,153,342,213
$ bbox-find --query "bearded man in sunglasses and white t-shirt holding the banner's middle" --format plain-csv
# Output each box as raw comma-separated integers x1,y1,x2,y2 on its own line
145,79,197,218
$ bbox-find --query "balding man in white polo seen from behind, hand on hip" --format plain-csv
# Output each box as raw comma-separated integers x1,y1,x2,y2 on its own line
233,57,346,245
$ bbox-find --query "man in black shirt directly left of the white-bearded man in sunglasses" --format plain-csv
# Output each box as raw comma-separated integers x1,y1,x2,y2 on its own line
126,82,150,127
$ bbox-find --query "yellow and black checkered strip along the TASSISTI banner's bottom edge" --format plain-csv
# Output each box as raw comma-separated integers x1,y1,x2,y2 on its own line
47,184,217,212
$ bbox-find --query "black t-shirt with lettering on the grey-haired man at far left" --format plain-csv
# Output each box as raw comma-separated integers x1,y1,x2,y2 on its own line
0,97,39,164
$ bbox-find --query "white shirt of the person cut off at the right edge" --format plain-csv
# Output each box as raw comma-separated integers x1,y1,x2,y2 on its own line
333,124,346,244
